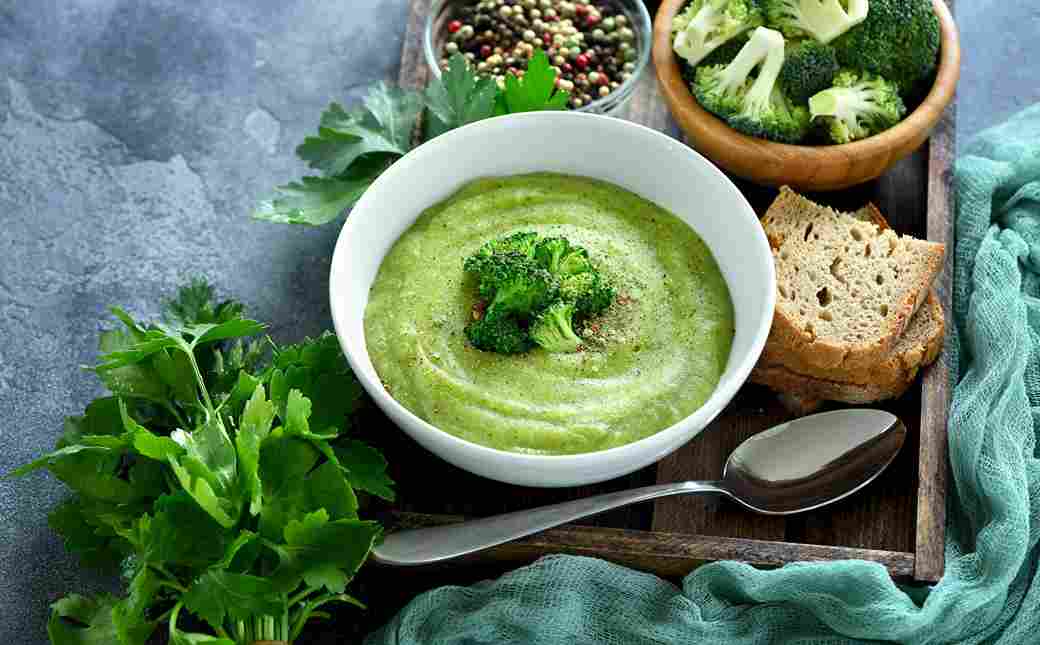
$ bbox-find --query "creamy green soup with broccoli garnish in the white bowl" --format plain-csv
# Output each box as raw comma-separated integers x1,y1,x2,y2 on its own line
365,174,733,455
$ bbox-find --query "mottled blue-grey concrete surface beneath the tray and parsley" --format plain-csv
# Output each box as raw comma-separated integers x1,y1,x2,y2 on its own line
0,0,1040,644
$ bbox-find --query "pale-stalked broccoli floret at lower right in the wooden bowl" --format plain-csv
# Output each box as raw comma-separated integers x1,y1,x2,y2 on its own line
809,70,907,144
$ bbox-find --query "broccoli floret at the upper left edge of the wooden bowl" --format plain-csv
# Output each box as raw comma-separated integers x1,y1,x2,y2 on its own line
672,0,762,67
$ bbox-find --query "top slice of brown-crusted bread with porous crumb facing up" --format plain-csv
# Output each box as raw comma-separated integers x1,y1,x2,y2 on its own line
762,186,944,372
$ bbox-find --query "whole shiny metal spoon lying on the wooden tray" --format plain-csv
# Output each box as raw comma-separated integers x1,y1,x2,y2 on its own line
372,410,907,566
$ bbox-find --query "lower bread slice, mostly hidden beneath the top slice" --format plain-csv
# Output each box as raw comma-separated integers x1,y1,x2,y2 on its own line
751,292,945,414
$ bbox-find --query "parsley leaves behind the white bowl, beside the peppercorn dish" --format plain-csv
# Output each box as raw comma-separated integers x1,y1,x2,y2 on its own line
253,50,569,226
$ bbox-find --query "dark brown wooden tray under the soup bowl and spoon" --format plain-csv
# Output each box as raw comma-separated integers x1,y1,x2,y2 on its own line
379,0,954,587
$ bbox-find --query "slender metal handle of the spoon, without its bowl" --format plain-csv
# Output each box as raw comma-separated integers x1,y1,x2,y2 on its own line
372,482,729,566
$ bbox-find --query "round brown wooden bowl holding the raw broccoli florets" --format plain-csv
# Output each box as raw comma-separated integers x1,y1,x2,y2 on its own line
653,0,961,190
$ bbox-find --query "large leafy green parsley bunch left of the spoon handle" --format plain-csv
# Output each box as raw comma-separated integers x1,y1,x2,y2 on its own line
12,281,393,645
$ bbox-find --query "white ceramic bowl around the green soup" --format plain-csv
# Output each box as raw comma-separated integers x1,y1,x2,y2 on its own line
329,111,776,487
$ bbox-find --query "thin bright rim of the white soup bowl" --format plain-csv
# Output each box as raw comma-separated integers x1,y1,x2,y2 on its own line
329,110,776,466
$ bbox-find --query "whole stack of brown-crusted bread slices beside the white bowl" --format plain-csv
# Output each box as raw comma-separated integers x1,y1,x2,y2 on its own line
751,187,944,412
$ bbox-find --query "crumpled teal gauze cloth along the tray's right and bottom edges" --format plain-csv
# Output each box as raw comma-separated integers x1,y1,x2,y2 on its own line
367,105,1040,645
